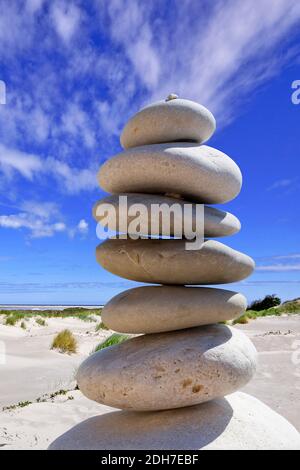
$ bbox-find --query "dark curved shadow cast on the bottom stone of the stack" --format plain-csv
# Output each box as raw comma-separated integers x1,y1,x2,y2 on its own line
49,398,233,450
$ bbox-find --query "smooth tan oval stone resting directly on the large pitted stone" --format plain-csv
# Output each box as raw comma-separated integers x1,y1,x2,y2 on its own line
101,286,247,334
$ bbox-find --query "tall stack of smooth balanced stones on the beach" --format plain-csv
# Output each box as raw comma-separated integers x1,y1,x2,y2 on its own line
67,95,297,449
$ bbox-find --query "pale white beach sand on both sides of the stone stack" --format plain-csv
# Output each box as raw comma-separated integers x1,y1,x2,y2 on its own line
0,315,300,450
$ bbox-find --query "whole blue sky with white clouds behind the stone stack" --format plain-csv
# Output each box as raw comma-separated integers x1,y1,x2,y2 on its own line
0,0,300,304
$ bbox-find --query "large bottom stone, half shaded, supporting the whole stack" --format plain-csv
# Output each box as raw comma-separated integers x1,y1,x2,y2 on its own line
49,392,300,452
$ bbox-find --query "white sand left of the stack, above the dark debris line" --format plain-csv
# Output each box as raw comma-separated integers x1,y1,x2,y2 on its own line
0,316,111,409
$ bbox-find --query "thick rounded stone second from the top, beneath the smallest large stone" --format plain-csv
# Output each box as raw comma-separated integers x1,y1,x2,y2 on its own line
98,142,242,204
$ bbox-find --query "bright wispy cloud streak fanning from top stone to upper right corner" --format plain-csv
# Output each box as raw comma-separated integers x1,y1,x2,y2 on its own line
153,0,300,119
